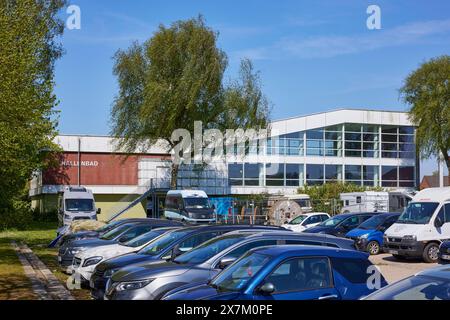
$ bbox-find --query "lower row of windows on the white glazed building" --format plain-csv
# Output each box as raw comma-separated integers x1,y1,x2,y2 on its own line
228,163,415,188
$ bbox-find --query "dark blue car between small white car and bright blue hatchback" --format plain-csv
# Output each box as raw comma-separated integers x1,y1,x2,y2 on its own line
304,212,379,237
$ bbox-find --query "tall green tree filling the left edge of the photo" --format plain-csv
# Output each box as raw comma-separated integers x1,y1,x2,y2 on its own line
0,0,65,226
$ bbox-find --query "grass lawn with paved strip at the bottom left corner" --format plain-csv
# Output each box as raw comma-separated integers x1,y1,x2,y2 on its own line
0,222,89,300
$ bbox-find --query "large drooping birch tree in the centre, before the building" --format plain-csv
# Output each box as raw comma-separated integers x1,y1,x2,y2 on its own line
111,16,269,188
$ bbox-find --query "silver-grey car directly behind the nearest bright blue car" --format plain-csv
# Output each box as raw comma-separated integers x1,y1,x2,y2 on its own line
106,230,354,300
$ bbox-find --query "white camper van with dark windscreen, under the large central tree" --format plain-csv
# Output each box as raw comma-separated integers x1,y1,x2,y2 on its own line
164,190,215,224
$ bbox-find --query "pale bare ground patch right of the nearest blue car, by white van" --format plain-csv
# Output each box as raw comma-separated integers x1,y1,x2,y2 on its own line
370,254,437,283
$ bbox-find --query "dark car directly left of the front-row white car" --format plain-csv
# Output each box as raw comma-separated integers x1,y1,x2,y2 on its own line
58,219,179,273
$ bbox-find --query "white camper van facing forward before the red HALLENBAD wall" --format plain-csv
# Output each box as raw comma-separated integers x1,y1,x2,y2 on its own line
58,186,101,226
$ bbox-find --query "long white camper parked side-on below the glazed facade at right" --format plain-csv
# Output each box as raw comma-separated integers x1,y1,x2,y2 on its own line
340,191,412,213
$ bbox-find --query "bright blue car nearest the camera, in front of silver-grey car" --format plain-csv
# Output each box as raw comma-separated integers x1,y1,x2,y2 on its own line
163,245,387,300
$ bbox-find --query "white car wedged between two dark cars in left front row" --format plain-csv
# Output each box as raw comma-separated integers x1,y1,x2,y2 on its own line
69,227,176,281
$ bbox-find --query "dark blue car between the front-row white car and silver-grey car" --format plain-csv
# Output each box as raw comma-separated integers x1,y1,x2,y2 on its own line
90,225,284,299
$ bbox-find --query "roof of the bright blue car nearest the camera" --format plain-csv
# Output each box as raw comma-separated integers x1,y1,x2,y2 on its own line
251,245,368,259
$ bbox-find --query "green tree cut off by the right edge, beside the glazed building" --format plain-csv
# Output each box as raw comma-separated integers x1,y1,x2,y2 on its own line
400,55,450,172
